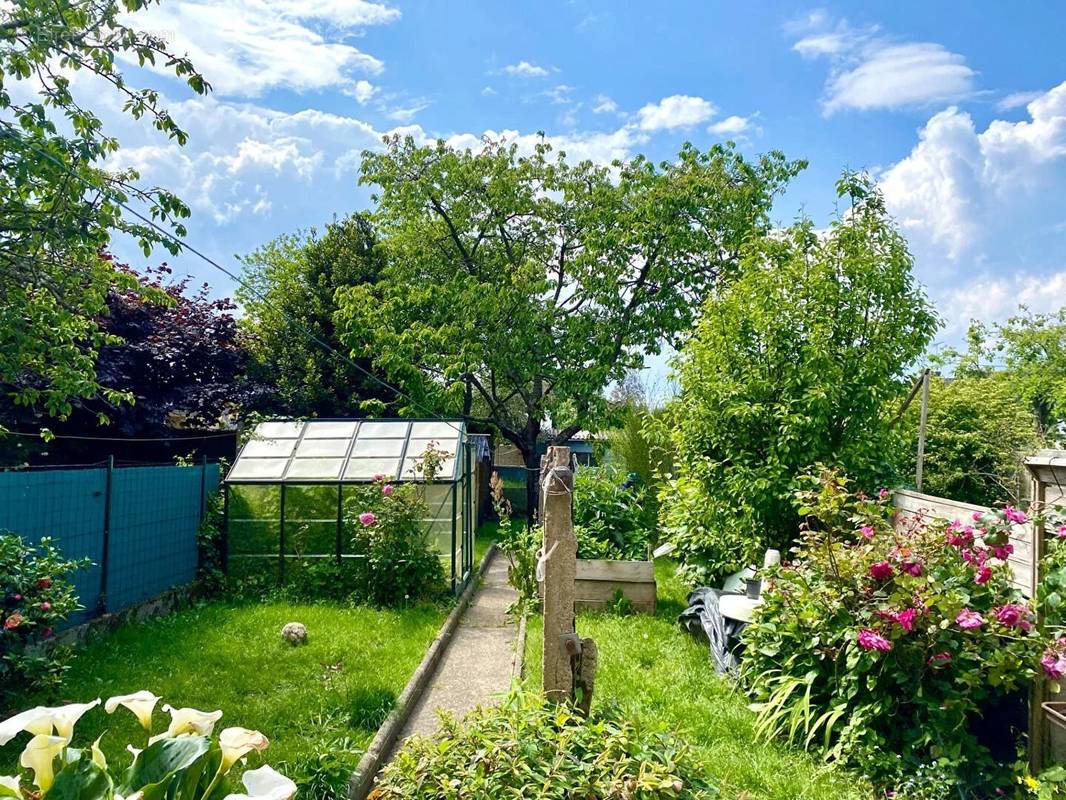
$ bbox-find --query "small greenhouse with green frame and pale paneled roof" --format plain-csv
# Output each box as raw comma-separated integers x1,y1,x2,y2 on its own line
223,419,475,592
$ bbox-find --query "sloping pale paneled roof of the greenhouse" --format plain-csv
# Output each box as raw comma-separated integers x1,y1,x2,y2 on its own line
226,419,466,483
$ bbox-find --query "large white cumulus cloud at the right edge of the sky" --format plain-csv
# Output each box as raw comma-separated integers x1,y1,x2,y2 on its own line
879,82,1066,334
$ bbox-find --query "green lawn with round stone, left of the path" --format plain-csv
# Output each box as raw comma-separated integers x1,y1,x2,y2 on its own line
0,603,447,798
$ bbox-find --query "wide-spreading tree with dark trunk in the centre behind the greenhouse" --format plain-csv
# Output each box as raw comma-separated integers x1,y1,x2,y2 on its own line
338,138,802,508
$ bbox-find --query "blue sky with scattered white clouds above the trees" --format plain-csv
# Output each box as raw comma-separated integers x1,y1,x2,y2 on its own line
87,0,1066,356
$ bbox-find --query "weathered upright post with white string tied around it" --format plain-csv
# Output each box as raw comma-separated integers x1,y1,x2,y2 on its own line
540,447,578,703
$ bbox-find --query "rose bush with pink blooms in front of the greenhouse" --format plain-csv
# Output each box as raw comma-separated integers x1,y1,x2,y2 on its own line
344,478,445,606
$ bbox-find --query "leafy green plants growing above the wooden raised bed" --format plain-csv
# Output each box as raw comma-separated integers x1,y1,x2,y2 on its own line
574,466,656,560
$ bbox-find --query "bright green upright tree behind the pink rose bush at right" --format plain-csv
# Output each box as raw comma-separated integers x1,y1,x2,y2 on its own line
660,175,937,578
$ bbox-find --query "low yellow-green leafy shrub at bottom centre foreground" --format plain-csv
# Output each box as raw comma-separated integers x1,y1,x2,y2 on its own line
370,691,717,800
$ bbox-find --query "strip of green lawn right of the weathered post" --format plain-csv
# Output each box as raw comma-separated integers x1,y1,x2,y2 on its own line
526,561,873,800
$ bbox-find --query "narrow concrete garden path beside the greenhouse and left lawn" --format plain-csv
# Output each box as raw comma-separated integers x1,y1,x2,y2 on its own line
397,551,518,749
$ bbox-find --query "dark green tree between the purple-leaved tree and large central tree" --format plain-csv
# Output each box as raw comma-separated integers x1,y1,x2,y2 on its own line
237,214,397,417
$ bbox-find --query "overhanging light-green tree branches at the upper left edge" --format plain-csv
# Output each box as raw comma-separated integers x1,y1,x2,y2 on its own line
0,0,209,416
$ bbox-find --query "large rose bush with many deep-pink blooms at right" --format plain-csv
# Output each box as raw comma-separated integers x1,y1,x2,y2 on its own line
742,471,1041,798
